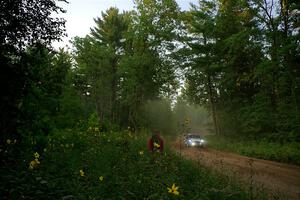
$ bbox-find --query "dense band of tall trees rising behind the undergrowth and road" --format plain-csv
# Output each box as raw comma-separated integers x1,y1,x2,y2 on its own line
0,0,300,140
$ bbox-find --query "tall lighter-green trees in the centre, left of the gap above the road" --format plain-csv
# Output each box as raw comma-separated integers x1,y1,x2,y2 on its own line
73,0,180,130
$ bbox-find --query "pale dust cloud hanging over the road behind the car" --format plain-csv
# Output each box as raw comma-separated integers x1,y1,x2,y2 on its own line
143,99,212,136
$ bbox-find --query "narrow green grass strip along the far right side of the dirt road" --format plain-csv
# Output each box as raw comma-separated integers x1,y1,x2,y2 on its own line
205,135,300,165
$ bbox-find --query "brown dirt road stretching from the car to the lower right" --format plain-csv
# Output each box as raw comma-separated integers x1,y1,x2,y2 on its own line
171,141,300,200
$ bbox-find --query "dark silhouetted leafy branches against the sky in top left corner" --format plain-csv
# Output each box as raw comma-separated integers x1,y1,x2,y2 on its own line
0,0,67,51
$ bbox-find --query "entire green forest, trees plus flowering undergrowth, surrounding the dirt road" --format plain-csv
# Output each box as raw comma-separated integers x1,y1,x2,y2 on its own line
0,0,300,199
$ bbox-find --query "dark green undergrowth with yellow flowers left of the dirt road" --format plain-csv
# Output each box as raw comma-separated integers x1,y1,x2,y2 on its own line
0,128,265,200
